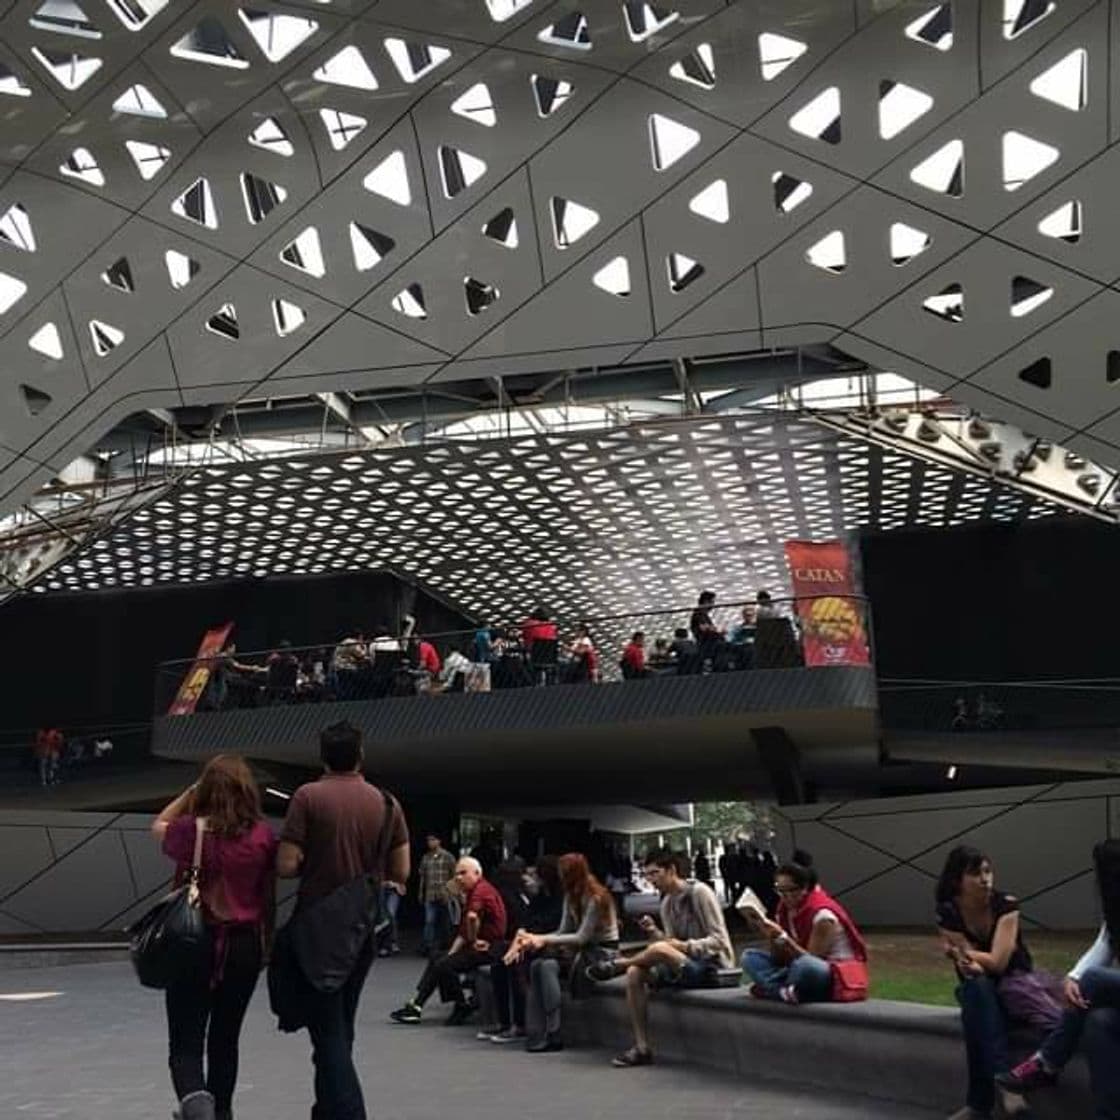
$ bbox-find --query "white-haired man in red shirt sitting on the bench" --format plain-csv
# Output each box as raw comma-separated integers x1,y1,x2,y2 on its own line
389,856,506,1027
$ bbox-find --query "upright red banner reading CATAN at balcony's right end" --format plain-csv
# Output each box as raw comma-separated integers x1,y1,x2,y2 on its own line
785,541,871,665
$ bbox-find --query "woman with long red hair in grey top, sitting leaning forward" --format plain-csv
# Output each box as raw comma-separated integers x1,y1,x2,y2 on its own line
505,851,618,1054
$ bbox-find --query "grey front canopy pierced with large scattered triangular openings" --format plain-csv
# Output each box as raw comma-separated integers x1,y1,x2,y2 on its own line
0,0,1120,528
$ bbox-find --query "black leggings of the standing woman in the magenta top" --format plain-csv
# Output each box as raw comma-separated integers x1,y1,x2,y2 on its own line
166,926,261,1114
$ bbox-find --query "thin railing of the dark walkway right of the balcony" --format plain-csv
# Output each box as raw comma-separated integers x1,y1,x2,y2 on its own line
879,678,1120,734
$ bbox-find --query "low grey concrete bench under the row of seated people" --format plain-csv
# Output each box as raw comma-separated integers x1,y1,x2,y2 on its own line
564,979,1092,1120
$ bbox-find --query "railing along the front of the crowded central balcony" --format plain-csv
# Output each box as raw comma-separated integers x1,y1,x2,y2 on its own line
155,596,872,715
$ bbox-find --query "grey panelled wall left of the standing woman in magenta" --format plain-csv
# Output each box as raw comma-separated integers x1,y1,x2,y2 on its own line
0,811,293,936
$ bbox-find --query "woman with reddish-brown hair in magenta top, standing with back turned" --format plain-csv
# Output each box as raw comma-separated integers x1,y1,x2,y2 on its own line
151,755,277,1120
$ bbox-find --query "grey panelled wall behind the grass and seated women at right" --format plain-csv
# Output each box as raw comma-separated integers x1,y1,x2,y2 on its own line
776,780,1120,930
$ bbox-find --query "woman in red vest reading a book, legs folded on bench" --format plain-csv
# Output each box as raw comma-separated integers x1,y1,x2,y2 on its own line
739,864,868,1004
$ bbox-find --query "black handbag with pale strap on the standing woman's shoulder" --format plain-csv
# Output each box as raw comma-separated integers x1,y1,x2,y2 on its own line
127,818,211,988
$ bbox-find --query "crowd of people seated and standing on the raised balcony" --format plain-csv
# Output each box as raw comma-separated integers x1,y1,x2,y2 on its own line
192,590,815,710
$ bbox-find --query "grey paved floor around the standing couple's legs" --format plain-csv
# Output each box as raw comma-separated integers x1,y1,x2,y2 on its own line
0,958,937,1120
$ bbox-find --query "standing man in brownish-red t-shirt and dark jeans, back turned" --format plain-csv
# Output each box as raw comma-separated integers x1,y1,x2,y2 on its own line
277,724,410,1120
